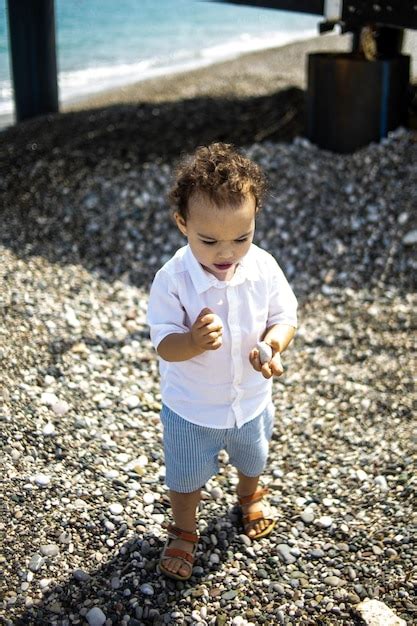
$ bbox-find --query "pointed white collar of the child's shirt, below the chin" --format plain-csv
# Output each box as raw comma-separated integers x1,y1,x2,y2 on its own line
184,245,260,294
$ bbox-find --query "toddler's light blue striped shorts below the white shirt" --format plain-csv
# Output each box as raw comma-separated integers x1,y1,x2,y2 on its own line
161,402,275,493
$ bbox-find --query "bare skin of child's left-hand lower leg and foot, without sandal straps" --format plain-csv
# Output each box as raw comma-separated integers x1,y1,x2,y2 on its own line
163,489,201,576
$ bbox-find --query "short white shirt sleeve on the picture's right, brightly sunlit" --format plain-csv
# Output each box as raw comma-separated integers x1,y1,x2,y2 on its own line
268,255,298,328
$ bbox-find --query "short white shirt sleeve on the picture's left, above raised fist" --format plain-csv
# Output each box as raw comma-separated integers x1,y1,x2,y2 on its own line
147,269,189,349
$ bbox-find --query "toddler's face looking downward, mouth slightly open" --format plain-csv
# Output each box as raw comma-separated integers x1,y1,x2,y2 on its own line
175,194,256,280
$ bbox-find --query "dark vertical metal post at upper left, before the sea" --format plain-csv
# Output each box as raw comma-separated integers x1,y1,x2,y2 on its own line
8,0,59,122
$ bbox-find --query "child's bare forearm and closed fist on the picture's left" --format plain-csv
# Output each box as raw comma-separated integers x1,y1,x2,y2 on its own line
157,308,222,361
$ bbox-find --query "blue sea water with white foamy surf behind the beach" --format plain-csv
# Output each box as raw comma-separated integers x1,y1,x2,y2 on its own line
0,0,317,114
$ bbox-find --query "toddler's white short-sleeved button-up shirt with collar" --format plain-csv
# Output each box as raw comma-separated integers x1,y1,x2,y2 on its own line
147,244,297,428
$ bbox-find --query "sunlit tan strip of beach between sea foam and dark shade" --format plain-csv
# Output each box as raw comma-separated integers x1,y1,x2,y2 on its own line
0,34,350,132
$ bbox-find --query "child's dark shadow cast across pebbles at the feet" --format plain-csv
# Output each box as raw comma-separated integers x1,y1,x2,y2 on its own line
14,503,242,626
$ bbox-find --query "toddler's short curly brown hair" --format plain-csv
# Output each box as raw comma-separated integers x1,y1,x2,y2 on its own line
168,142,266,221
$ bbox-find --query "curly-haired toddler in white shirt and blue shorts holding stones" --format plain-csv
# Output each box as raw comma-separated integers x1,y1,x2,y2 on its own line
148,143,297,580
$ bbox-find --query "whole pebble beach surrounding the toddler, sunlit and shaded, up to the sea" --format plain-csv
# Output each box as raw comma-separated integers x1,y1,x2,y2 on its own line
0,37,417,626
